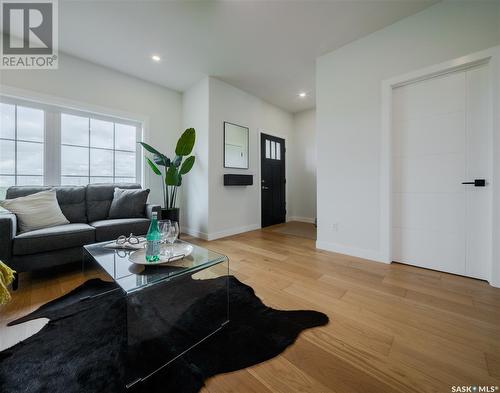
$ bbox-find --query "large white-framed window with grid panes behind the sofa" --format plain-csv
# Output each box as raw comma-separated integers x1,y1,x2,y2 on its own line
0,97,142,199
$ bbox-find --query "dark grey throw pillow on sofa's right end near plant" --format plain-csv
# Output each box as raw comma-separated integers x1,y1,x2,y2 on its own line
108,188,149,218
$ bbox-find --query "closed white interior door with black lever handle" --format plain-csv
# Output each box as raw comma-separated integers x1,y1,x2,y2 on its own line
392,65,493,278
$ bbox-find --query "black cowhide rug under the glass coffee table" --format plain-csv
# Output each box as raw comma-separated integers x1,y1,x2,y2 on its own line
0,276,328,393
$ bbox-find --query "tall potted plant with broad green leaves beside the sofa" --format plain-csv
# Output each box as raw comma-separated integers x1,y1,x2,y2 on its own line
139,128,196,222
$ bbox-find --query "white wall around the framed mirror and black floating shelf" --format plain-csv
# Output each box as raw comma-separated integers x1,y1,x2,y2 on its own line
208,78,293,239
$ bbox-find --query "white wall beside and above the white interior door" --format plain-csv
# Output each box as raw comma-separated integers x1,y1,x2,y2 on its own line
316,1,500,260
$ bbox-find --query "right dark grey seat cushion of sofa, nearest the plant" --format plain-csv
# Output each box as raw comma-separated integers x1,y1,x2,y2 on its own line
90,218,150,242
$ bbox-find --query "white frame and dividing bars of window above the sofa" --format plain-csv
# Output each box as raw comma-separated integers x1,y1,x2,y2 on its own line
0,95,144,186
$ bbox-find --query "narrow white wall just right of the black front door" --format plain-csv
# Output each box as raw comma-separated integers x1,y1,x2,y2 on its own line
287,109,316,222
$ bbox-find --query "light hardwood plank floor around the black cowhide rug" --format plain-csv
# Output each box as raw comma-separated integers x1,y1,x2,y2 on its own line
0,224,500,393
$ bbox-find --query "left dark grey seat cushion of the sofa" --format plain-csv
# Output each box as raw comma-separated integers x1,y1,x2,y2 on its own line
12,223,95,255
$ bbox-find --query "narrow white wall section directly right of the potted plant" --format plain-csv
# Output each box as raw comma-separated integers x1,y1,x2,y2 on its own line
180,78,210,239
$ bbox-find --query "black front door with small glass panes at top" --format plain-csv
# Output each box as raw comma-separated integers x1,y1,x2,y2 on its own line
260,134,286,227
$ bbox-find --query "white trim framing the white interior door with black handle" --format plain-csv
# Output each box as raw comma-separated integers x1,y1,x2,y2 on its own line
380,46,500,287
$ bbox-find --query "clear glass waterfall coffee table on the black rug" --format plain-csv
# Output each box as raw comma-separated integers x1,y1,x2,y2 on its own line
83,240,229,388
